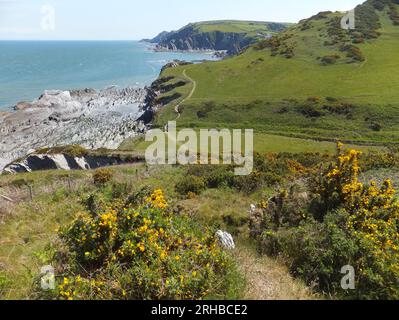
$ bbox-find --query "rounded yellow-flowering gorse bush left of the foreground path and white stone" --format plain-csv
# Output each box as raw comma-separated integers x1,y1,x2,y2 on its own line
49,190,231,300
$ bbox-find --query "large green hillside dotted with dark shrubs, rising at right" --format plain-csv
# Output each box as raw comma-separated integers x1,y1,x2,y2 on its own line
152,0,399,143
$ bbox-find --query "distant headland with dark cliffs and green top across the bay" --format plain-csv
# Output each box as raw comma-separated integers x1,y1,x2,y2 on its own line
150,21,286,54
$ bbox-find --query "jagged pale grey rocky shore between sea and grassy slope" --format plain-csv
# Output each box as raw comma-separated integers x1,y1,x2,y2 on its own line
0,87,150,172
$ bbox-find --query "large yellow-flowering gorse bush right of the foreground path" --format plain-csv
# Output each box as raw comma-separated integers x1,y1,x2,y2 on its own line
255,144,399,299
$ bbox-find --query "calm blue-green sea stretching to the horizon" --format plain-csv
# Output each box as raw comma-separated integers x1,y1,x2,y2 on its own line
0,41,217,111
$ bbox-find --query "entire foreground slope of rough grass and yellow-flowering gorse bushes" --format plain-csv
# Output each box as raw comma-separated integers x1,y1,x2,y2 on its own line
0,146,399,299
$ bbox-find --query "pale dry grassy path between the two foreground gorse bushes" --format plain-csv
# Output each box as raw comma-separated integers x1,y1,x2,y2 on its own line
235,245,317,300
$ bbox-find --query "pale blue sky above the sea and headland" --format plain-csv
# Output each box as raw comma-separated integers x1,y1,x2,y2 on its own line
0,0,364,40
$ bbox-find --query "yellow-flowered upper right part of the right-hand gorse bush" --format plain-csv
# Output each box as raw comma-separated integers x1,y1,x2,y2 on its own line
318,144,399,277
